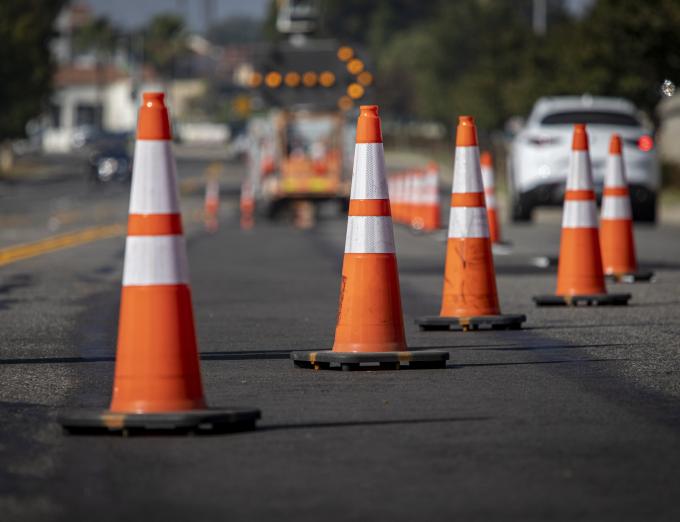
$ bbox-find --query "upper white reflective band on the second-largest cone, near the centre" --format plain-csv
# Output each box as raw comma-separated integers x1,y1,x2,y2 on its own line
350,143,387,199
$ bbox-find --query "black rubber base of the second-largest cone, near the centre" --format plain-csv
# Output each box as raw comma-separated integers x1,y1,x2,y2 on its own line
290,350,449,371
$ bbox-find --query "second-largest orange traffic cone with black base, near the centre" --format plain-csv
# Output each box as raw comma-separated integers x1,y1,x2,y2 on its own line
291,105,448,370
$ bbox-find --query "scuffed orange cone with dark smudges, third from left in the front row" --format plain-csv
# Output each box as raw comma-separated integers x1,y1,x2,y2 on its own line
416,116,526,330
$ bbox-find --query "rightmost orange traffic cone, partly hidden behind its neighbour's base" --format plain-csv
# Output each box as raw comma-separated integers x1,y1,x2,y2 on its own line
600,134,654,283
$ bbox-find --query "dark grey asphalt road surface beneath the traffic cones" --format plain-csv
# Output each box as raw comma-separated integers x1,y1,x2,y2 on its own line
0,152,680,522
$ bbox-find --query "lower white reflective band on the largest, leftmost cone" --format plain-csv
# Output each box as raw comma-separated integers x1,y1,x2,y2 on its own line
123,236,189,286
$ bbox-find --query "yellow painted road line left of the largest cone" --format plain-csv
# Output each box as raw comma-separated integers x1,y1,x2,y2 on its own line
0,223,125,266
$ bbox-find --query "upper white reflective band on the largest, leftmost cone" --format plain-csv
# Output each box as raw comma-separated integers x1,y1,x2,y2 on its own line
130,140,179,214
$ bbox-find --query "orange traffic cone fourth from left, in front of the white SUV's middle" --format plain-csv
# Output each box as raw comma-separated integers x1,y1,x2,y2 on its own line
534,123,630,306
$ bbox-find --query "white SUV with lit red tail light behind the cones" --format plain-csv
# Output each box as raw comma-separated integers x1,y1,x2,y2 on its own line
507,95,659,222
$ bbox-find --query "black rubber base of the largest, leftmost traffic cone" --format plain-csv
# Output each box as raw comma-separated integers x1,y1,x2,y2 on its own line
58,408,260,436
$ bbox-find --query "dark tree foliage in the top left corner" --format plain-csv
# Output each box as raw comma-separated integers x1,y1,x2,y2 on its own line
0,0,65,141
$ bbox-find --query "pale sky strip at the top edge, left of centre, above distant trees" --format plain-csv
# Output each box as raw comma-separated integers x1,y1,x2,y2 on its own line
80,0,270,31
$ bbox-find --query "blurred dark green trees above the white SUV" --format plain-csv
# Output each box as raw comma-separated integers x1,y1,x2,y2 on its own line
270,0,680,129
